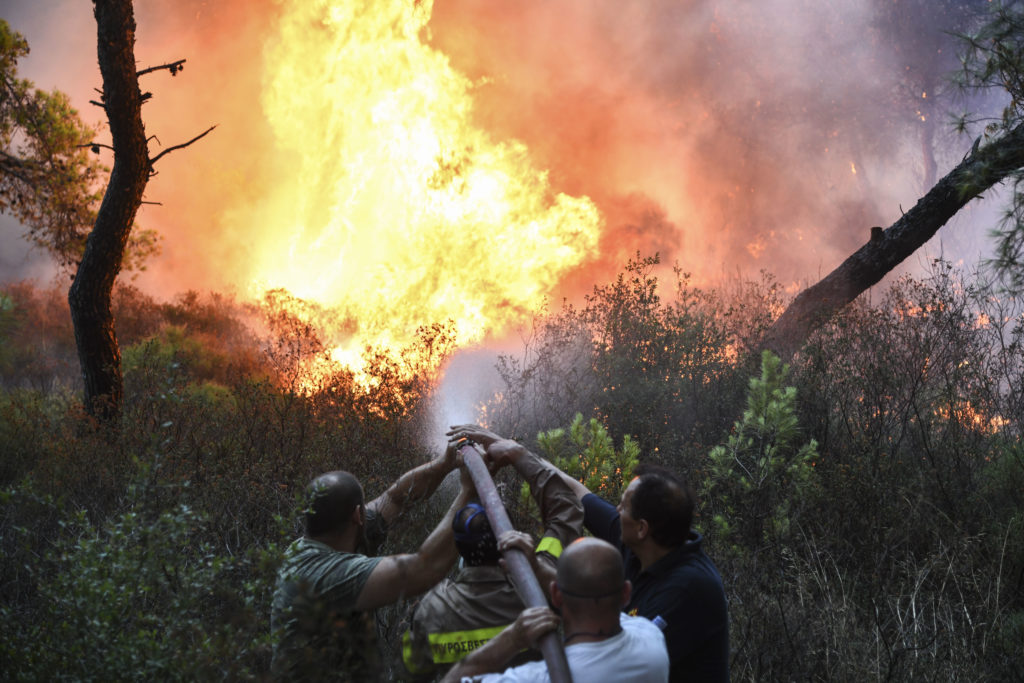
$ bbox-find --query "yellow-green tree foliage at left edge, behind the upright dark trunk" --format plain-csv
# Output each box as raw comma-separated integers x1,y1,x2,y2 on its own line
0,19,159,270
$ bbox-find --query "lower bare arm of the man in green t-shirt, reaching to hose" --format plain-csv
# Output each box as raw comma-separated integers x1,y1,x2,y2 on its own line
355,462,475,610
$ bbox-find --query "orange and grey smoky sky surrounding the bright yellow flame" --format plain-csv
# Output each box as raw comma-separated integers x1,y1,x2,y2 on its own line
0,0,995,325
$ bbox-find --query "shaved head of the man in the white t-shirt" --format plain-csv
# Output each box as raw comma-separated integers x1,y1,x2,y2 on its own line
558,538,626,612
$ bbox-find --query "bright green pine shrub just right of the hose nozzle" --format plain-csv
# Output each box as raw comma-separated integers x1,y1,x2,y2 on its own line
523,413,640,502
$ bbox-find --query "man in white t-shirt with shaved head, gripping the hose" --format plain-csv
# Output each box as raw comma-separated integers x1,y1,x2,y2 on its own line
442,538,669,683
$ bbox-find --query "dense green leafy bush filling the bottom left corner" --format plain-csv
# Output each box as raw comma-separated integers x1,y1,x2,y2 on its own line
0,471,283,681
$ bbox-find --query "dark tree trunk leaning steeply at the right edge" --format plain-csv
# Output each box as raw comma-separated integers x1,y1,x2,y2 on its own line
763,124,1024,358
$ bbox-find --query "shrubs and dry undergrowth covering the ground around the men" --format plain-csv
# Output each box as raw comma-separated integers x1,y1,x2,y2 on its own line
0,263,1024,681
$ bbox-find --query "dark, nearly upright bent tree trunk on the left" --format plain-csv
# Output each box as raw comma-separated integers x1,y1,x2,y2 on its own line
68,0,151,420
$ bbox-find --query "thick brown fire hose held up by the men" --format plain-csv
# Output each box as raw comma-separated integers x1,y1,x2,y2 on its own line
459,440,572,683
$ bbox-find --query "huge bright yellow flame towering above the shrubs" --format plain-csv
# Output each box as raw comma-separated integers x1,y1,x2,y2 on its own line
234,0,601,368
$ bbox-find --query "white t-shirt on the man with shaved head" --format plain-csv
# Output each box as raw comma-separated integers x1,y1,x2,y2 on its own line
471,614,669,683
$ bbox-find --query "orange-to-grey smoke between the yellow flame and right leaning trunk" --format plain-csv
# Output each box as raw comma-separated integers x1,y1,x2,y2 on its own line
423,0,999,290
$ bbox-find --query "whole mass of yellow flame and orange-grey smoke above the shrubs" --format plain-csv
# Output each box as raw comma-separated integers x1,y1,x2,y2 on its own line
5,0,976,385
